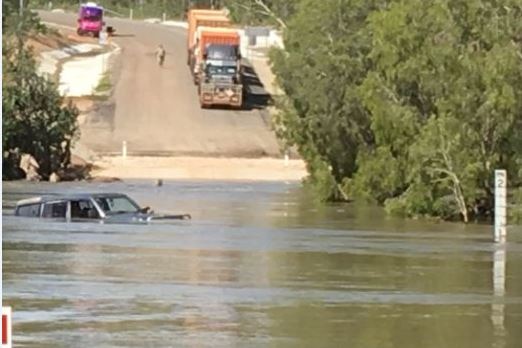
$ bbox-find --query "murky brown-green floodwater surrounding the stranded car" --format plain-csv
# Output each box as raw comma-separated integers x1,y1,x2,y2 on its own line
3,182,522,348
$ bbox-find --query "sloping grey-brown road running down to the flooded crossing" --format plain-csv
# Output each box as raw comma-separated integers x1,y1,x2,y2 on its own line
40,12,279,157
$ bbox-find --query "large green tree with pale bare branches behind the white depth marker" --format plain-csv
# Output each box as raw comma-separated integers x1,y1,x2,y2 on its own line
354,0,522,221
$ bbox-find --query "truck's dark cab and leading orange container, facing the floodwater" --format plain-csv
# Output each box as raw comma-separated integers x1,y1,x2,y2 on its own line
194,27,243,107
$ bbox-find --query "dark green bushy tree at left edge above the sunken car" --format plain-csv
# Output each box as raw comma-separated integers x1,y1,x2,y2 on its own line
2,1,78,180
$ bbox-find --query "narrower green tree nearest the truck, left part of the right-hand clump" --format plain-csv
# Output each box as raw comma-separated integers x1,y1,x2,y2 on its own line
271,0,384,198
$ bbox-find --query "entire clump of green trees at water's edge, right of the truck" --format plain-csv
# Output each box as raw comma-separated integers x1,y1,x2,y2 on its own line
266,0,522,222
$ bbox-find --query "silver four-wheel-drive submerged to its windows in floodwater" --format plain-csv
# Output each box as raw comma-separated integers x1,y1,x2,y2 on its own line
14,193,191,223
